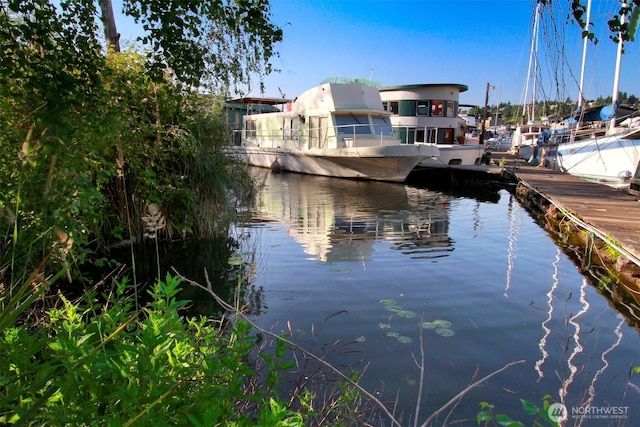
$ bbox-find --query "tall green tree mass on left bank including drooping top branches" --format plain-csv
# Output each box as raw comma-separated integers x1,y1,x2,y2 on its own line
0,0,282,288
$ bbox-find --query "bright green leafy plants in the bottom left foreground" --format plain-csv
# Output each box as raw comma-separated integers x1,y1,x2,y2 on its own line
0,276,309,426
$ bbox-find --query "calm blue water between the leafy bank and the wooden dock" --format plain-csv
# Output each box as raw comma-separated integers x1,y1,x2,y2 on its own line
230,170,640,426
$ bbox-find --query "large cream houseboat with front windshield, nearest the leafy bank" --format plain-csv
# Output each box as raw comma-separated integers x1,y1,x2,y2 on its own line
226,79,438,182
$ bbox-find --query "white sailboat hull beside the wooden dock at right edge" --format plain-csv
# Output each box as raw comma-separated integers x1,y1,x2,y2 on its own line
557,134,640,182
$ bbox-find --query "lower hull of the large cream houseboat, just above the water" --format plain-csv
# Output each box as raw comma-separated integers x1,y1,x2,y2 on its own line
232,144,438,182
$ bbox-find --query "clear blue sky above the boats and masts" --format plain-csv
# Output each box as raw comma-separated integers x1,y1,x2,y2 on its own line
114,0,640,105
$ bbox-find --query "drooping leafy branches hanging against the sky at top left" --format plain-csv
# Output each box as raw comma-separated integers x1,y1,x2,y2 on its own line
123,0,282,90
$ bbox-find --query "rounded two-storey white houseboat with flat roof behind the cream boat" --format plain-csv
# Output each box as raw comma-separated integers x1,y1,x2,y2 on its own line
380,83,484,166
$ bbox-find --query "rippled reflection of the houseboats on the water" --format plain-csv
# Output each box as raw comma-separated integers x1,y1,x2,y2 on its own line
254,171,454,262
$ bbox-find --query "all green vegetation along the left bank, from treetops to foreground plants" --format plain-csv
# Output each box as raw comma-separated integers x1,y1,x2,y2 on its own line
0,0,636,426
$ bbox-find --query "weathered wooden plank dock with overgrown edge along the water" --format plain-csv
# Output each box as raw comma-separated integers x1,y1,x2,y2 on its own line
500,153,640,310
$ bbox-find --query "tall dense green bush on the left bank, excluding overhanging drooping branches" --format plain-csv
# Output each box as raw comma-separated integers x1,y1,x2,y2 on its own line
0,0,255,287
